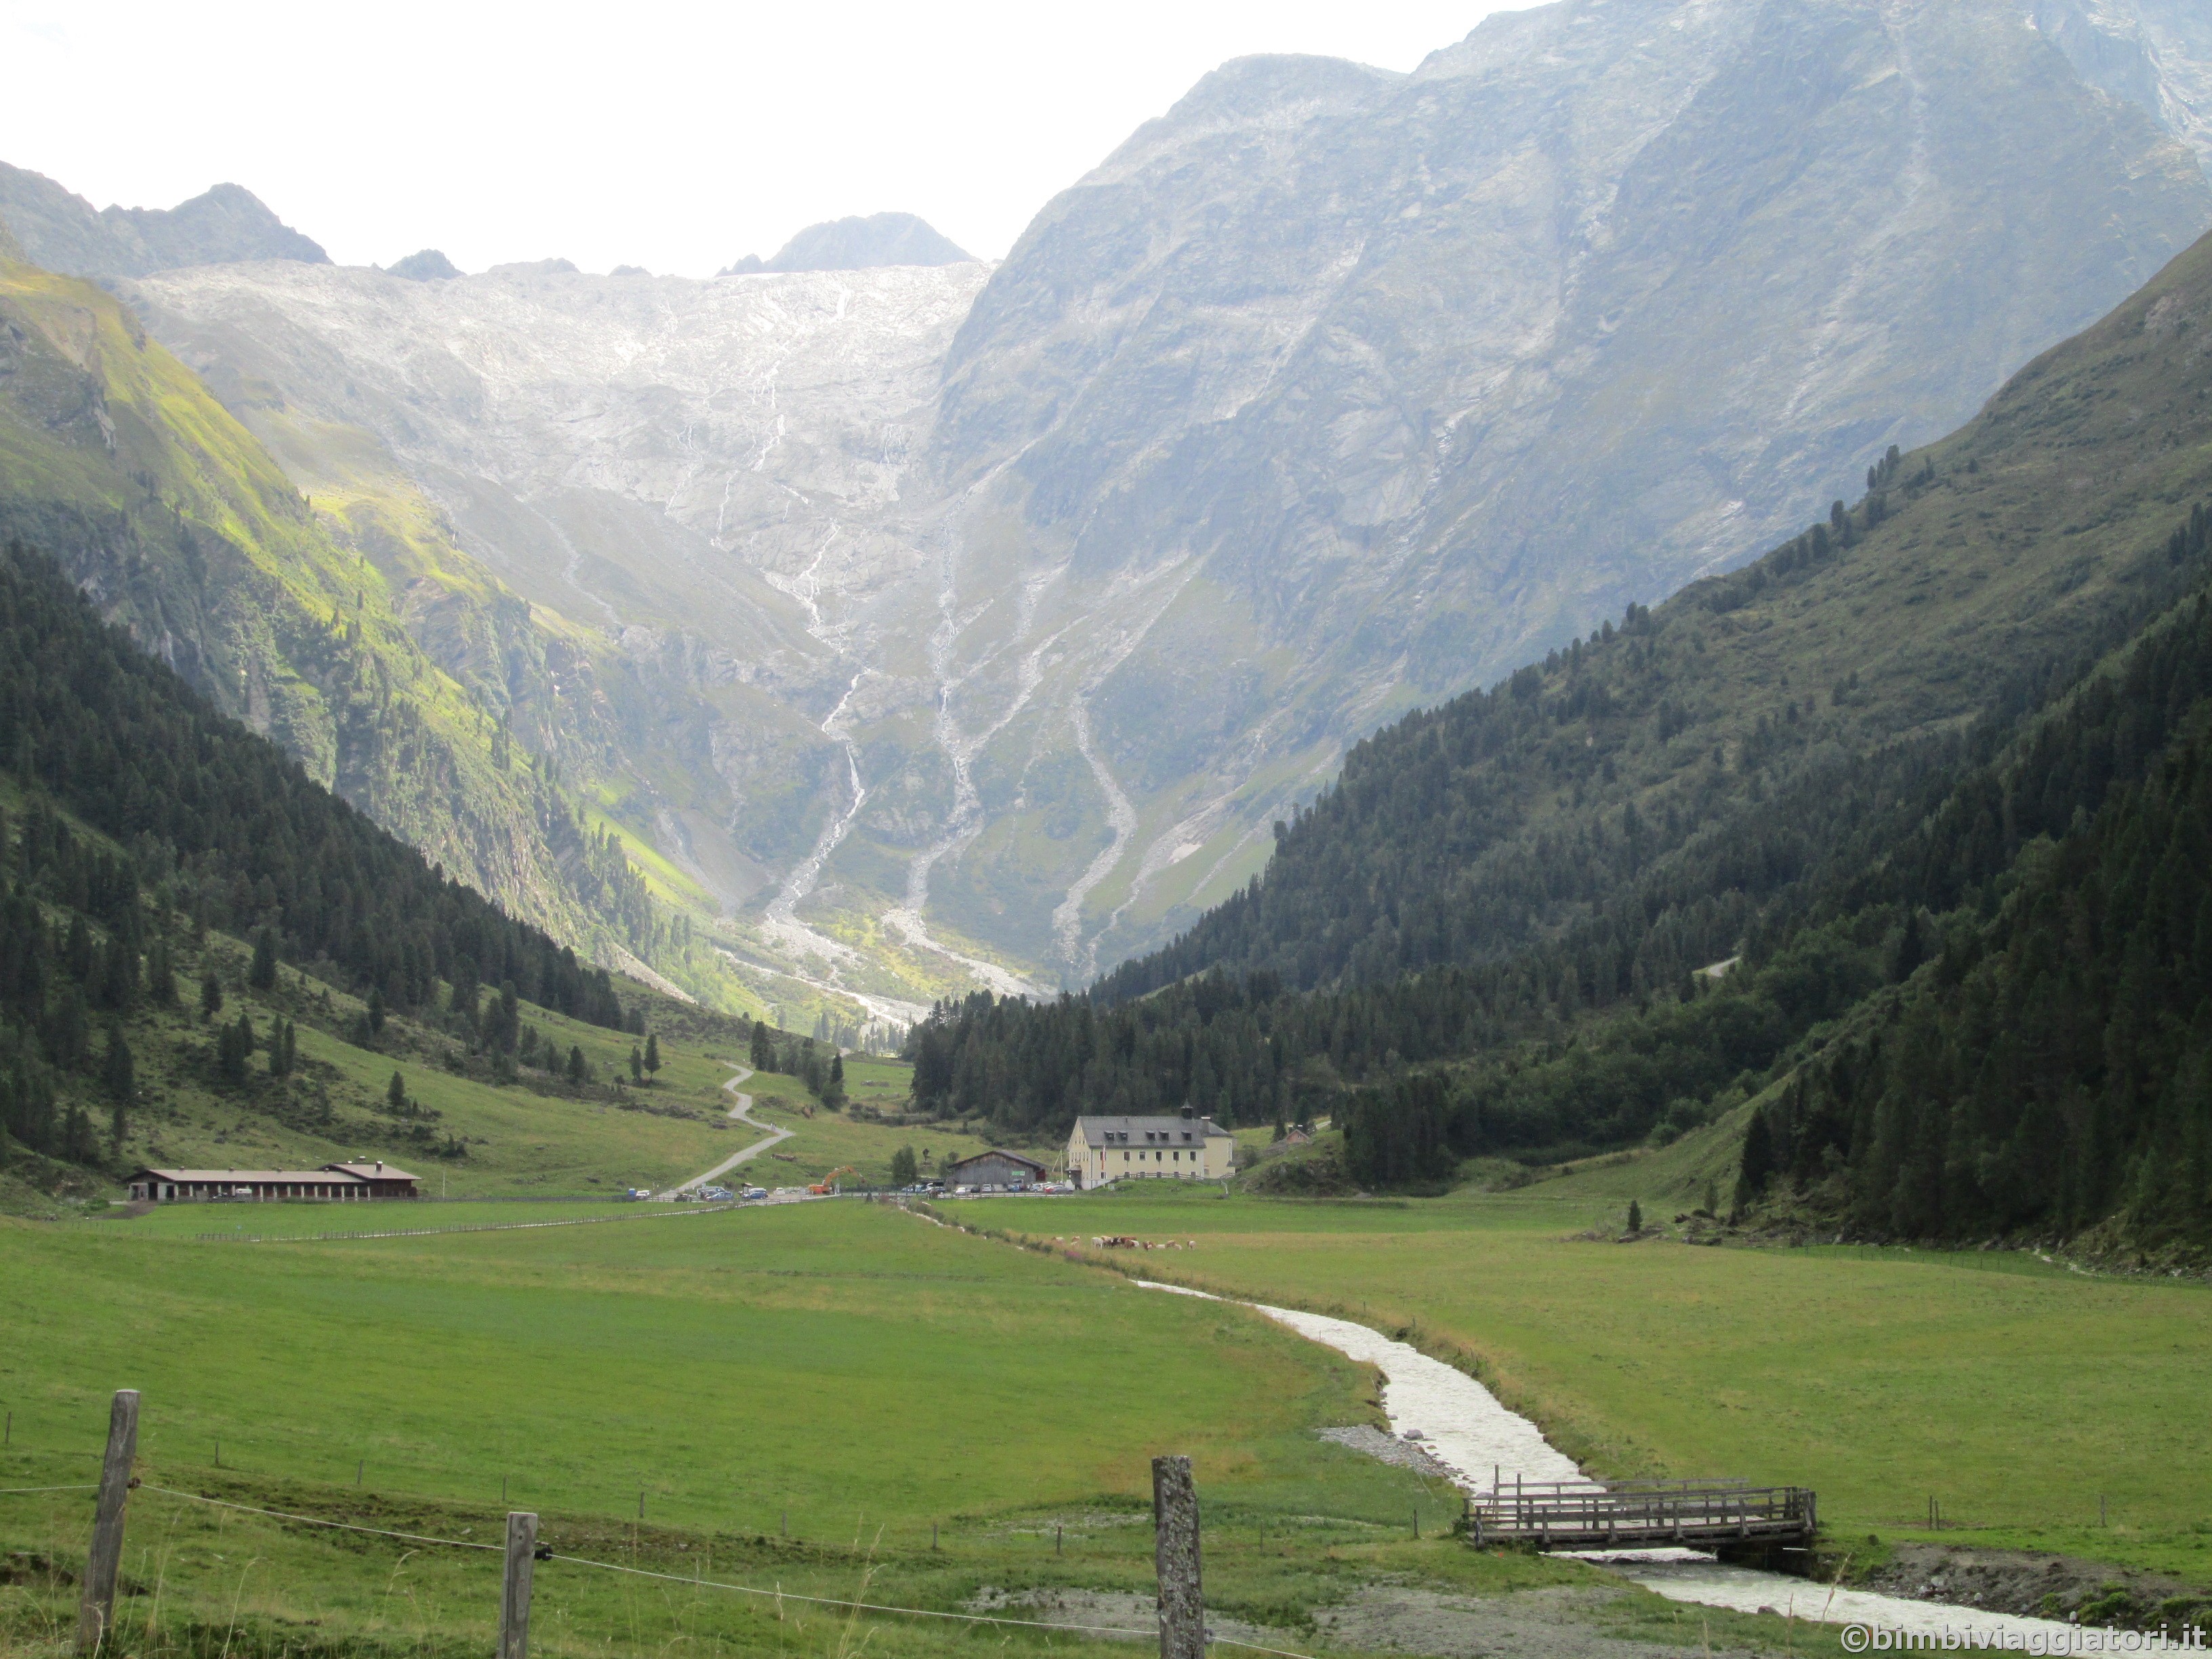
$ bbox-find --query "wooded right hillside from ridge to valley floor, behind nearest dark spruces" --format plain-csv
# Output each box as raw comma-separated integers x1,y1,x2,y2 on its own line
916,228,2212,1256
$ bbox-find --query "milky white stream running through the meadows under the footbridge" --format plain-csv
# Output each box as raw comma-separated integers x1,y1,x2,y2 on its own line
1137,1279,2079,1652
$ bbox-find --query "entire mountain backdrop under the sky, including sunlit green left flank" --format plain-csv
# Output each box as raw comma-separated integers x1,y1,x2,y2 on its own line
0,0,2212,1029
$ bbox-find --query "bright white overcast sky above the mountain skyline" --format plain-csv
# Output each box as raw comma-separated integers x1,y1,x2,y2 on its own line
0,0,1502,276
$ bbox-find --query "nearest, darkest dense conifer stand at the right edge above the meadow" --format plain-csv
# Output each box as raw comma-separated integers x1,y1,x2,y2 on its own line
1736,597,2212,1246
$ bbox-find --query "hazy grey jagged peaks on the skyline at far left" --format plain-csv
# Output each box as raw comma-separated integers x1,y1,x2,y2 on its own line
0,161,329,276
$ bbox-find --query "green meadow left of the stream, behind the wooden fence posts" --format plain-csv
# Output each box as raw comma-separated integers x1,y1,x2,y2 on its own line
0,1201,1858,1659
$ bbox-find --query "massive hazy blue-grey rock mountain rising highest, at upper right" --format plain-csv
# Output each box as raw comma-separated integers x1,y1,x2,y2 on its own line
931,0,2212,973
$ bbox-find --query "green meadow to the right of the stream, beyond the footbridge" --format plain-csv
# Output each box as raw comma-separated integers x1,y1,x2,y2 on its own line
1012,1183,2212,1584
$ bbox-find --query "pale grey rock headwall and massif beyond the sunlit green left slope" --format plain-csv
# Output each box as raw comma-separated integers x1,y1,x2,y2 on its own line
129,0,2212,1002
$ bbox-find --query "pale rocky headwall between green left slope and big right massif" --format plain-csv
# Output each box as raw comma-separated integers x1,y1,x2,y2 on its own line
126,261,1008,1022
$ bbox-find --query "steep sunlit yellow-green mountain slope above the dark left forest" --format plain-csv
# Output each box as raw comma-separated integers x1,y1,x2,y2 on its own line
0,263,672,973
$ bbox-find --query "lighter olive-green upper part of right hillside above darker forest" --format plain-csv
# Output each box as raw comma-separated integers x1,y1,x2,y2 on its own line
1099,214,2212,1000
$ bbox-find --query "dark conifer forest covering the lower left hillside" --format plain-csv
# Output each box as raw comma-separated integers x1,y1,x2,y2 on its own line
0,544,663,1164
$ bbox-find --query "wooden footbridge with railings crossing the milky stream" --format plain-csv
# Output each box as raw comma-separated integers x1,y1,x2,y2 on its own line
1467,1477,1820,1551
